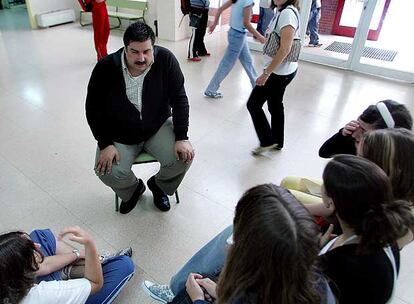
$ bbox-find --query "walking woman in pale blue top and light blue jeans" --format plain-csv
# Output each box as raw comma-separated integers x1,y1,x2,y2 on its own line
204,0,265,98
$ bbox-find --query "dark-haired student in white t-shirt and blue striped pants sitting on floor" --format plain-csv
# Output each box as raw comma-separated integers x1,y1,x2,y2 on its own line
0,227,134,304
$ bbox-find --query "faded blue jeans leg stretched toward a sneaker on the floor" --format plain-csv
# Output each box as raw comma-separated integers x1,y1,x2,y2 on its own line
170,225,233,295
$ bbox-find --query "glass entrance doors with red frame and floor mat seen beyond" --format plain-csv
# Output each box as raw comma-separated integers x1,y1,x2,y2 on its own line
301,0,414,82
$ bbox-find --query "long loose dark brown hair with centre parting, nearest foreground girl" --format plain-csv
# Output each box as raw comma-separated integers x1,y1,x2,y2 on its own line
217,184,320,304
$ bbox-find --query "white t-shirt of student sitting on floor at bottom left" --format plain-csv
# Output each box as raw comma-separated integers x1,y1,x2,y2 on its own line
20,278,92,304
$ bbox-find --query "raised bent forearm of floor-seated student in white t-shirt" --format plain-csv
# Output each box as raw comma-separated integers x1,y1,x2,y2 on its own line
59,226,103,294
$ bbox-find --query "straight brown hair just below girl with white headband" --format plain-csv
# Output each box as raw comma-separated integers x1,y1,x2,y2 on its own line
361,129,414,204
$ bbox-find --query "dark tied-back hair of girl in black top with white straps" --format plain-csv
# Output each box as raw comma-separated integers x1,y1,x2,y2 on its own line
323,155,414,254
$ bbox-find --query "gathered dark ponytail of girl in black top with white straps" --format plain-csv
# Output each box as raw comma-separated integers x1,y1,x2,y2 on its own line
355,200,414,254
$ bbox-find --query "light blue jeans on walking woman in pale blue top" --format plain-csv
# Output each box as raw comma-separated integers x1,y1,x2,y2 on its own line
206,28,257,93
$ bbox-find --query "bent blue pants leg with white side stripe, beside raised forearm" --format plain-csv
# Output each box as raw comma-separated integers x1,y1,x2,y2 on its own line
86,256,134,304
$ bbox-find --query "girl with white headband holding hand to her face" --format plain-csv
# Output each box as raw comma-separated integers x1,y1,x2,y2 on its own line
319,99,413,158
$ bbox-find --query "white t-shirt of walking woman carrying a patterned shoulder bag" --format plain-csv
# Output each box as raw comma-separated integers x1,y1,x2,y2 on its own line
264,5,300,75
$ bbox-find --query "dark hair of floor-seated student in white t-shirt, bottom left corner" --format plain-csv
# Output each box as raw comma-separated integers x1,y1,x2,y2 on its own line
0,231,43,303
